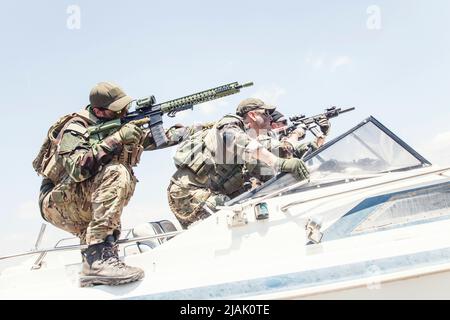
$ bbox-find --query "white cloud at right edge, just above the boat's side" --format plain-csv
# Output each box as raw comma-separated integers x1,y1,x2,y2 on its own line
421,131,450,165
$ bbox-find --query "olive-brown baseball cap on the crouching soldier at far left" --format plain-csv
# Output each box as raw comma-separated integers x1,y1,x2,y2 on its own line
89,82,133,112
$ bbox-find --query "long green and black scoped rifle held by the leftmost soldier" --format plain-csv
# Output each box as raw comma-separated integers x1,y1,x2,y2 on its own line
88,82,253,147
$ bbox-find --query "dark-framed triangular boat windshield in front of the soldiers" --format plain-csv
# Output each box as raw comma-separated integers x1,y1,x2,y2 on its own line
230,117,430,204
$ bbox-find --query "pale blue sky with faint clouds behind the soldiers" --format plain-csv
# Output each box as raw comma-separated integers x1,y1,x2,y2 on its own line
0,0,450,254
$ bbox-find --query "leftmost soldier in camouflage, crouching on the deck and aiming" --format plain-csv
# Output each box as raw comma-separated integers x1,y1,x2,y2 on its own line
33,82,184,286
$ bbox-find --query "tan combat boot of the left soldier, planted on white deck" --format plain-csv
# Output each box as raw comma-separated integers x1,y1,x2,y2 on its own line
80,236,144,287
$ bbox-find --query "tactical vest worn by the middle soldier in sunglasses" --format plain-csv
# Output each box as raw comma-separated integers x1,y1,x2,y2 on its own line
174,115,245,195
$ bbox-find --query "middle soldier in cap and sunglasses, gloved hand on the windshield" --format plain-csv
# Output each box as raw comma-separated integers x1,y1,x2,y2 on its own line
167,98,308,228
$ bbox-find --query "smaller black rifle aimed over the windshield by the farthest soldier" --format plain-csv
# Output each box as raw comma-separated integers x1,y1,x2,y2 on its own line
276,107,355,137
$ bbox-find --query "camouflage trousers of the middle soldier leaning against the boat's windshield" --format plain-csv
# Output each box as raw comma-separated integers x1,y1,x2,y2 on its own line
167,181,230,229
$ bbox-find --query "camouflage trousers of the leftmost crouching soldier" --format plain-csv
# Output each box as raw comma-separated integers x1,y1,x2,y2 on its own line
42,163,137,245
